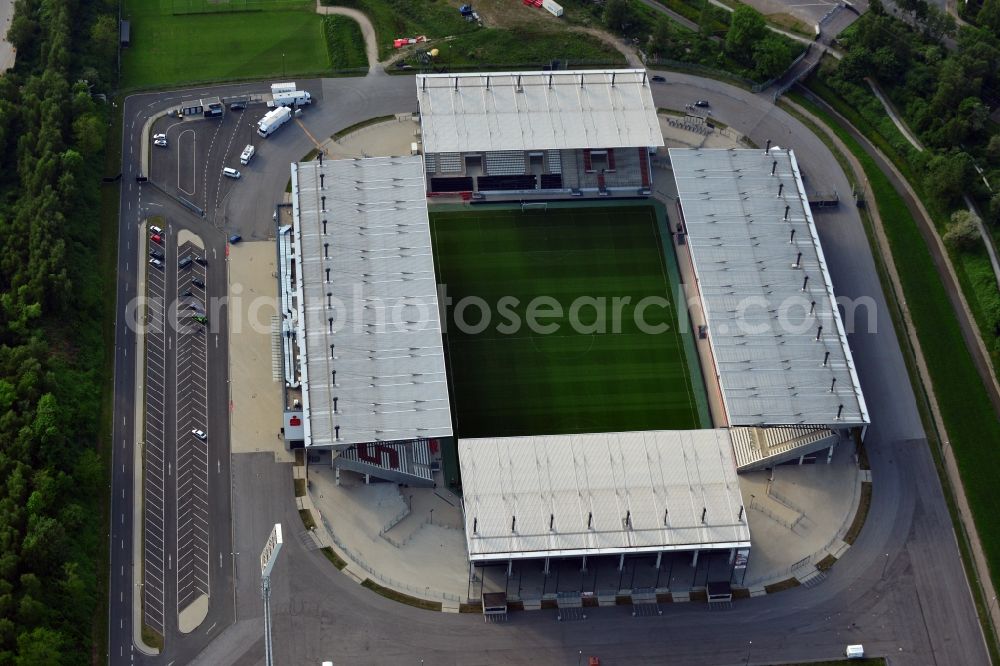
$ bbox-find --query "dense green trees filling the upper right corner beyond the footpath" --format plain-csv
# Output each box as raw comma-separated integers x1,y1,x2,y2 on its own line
824,0,1000,219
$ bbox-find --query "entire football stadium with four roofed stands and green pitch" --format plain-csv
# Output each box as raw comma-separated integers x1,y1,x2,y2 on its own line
276,70,869,613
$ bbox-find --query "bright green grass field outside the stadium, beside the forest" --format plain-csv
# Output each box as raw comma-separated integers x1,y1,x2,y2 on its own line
122,0,367,89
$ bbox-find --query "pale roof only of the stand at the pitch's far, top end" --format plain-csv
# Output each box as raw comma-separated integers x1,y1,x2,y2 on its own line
417,69,663,153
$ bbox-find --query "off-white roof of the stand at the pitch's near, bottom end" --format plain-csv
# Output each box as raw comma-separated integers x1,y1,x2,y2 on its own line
458,429,750,562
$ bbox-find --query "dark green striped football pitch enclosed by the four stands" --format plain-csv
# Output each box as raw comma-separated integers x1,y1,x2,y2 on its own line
431,204,710,438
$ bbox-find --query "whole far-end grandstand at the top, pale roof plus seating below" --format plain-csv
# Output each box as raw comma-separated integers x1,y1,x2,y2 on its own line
417,70,663,199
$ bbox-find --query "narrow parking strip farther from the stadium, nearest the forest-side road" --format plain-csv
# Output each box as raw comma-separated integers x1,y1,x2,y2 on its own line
143,227,169,634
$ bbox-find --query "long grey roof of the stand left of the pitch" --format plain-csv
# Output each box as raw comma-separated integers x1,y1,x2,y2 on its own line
292,155,452,446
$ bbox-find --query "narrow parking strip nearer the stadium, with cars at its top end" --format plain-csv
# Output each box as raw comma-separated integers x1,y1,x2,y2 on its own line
174,240,211,612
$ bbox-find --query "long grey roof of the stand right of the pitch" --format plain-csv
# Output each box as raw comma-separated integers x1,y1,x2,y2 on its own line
670,148,869,426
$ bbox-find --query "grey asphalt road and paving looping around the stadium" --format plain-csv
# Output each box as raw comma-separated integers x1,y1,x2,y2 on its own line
110,73,988,666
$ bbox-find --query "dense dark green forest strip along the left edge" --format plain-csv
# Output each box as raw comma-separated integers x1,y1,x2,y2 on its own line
0,0,118,652
